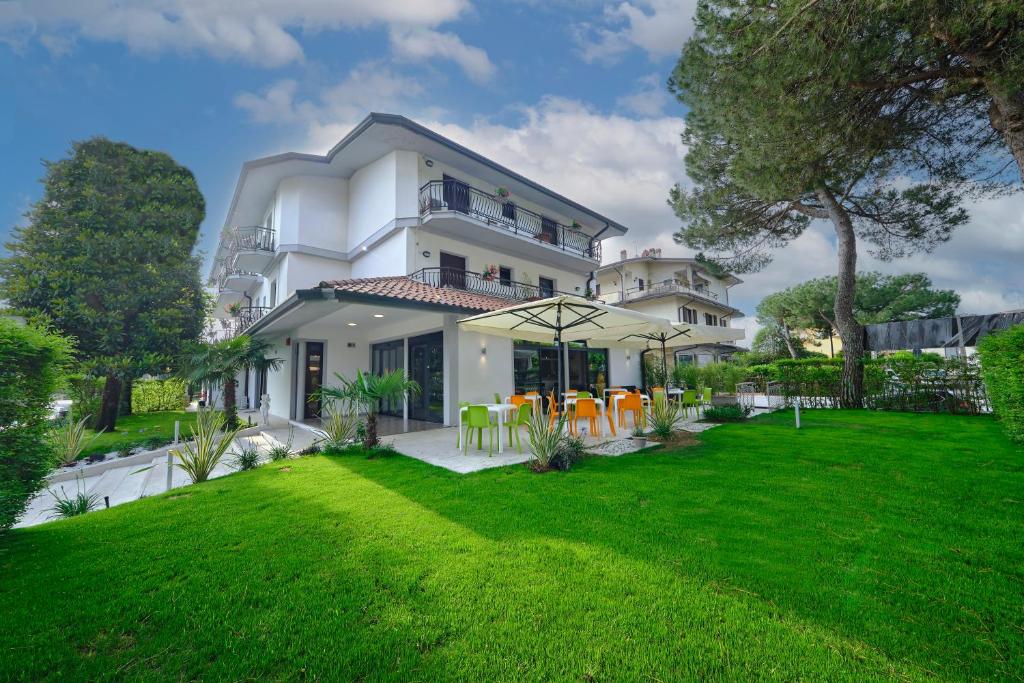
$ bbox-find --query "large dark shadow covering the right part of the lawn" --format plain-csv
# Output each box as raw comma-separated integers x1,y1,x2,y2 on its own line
311,412,1024,673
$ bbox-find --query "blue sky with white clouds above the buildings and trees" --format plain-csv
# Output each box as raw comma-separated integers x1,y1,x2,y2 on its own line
0,0,1024,338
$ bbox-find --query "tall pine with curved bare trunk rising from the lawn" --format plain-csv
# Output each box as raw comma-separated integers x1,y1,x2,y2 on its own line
670,0,987,405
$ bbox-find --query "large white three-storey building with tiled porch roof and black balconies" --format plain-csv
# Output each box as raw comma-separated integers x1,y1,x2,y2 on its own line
211,114,640,424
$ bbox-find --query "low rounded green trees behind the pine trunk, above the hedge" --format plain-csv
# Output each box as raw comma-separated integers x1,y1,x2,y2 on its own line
758,272,959,358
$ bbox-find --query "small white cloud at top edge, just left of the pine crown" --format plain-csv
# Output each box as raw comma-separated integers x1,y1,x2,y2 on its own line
574,0,697,62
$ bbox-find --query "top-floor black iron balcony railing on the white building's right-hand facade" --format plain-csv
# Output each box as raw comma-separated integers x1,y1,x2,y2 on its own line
420,180,601,261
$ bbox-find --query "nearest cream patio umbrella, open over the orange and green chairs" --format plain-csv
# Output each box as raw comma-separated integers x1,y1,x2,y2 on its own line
459,295,675,396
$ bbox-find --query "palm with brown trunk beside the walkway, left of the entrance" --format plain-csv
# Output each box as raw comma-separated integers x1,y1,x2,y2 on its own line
180,335,284,429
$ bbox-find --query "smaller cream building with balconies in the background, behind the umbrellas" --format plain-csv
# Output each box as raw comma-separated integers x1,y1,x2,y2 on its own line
594,249,744,367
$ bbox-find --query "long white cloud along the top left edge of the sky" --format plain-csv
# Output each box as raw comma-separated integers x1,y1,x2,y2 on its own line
0,0,468,67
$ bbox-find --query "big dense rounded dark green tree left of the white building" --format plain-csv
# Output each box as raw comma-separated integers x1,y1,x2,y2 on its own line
0,137,206,431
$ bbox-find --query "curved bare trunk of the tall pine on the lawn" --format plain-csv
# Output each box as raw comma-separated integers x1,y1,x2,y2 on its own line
817,186,864,408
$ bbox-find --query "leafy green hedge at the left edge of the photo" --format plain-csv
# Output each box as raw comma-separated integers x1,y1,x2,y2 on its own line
0,317,72,530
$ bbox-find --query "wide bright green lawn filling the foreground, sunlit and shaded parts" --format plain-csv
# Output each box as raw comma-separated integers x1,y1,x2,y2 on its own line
0,411,1024,682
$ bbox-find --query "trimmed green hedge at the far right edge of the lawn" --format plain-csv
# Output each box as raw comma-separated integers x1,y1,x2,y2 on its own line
978,324,1024,443
